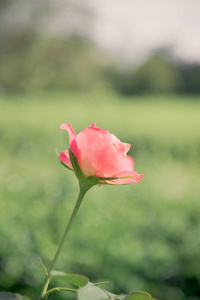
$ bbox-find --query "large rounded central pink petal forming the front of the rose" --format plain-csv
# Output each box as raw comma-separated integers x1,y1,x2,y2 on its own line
76,126,126,177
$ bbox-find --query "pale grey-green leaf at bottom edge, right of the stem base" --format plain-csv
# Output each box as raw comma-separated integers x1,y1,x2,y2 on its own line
78,282,110,300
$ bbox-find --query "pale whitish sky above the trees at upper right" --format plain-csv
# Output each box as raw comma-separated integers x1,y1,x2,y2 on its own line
85,0,200,62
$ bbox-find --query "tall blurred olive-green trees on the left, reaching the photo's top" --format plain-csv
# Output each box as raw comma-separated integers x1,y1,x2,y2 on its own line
0,0,105,92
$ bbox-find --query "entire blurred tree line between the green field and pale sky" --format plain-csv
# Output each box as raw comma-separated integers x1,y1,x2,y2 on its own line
0,0,200,95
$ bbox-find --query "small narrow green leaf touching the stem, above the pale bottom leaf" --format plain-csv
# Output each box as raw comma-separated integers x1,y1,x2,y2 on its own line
51,271,89,287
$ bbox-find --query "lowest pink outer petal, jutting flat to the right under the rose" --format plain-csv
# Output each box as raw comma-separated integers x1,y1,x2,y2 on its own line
105,171,144,185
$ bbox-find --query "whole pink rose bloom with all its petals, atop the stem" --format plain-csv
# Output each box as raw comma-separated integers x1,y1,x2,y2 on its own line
59,123,143,184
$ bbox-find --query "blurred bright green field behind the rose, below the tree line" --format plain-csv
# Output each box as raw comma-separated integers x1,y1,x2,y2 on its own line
0,93,200,300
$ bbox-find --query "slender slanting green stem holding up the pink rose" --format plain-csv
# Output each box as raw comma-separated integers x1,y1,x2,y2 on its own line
38,181,93,300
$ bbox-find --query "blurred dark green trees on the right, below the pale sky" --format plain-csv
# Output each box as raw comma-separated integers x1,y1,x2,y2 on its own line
107,51,200,96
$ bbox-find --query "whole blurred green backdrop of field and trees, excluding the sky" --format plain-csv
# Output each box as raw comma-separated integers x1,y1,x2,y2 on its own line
0,0,200,300
